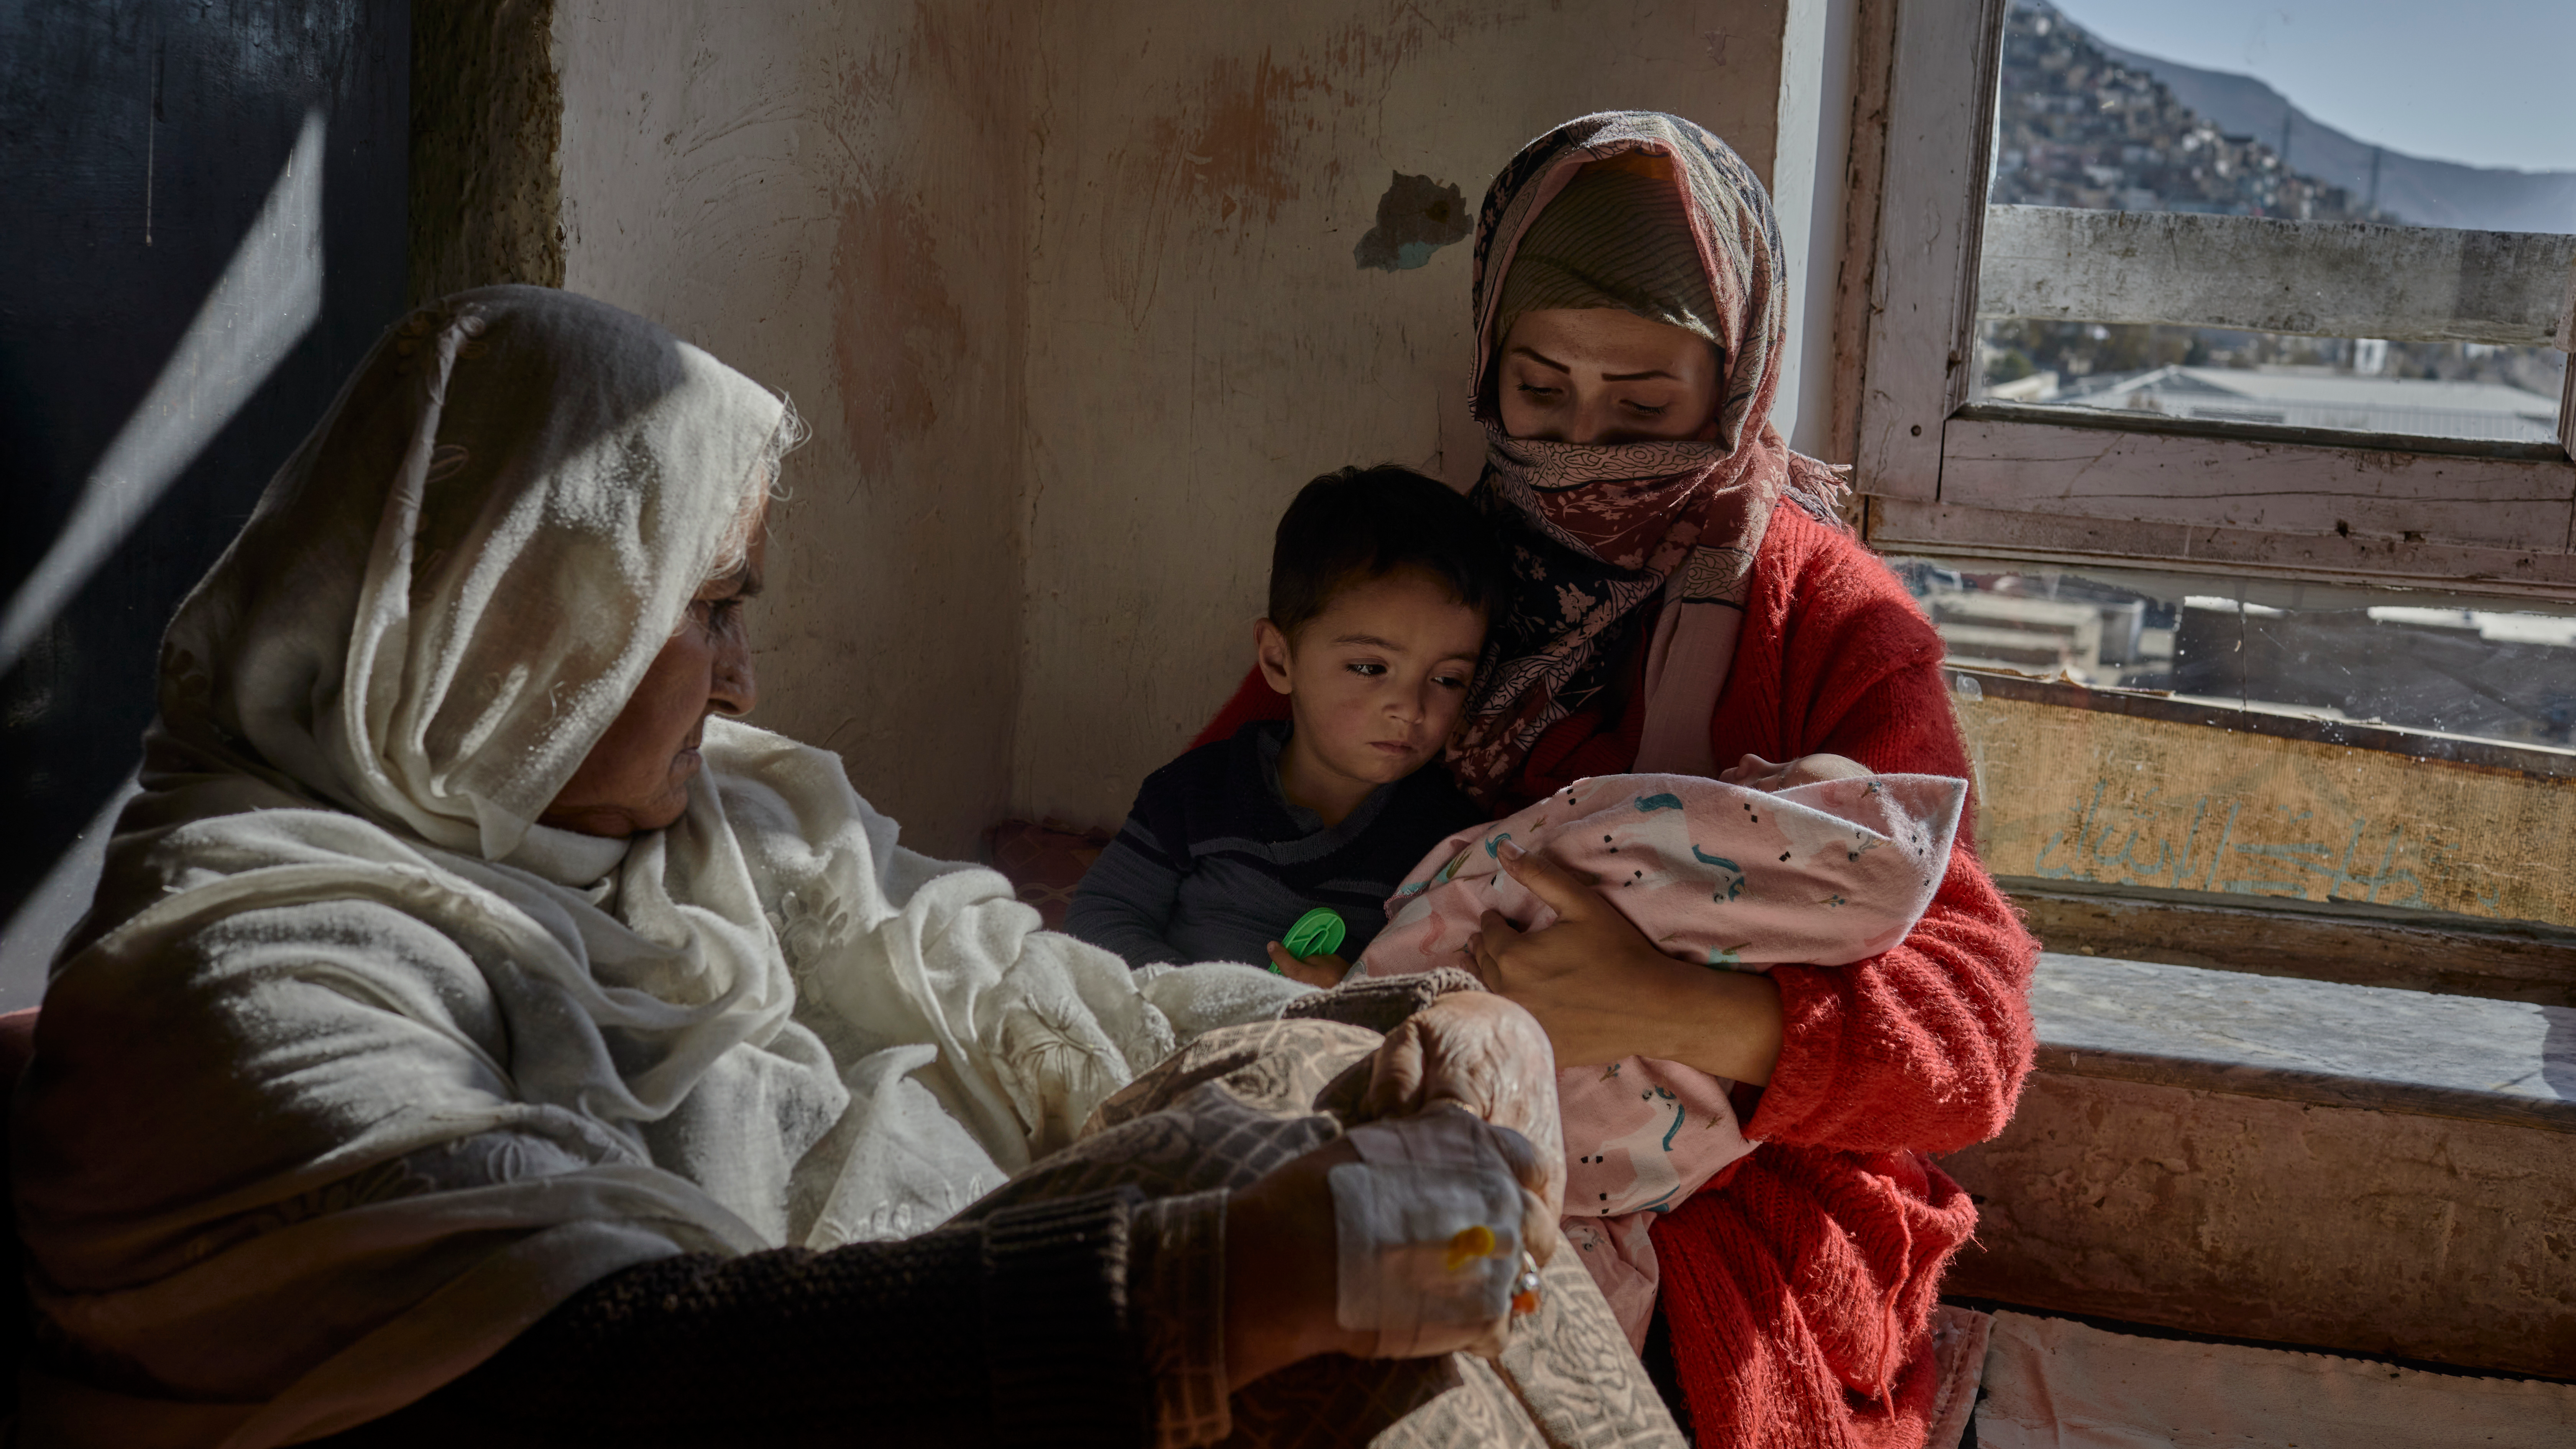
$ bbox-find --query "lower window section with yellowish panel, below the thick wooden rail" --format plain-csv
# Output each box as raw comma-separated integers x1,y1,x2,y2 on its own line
1888,554,2576,923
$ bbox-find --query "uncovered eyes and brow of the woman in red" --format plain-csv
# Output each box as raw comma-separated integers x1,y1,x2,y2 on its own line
1497,307,1721,444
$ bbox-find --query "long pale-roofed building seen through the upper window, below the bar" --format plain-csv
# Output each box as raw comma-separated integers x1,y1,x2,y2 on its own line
2050,361,2558,444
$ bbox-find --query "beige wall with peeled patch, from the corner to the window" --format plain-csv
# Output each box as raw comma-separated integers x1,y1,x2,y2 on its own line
1012,0,1788,825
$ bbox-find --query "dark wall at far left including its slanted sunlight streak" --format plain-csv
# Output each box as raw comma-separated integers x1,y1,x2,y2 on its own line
0,0,409,985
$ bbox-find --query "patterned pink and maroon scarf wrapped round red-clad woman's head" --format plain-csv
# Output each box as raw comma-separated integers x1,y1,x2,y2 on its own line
1450,111,1845,805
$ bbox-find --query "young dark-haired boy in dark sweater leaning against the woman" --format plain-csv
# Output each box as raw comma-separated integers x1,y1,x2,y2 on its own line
1064,467,1510,985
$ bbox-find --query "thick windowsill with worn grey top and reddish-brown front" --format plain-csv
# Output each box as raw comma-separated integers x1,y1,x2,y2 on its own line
1942,954,2576,1377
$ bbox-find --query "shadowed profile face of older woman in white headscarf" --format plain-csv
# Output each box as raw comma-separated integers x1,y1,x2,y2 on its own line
538,523,768,841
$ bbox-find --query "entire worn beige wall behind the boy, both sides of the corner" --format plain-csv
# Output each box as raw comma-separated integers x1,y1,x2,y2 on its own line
554,0,1793,853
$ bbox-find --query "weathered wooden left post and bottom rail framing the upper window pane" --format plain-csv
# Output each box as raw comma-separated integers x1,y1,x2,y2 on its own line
1852,0,2576,601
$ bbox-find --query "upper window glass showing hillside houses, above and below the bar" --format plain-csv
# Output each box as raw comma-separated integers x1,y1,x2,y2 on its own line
1973,0,2576,444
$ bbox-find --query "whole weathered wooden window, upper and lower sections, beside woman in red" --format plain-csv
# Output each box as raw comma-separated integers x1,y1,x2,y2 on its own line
1852,0,2576,959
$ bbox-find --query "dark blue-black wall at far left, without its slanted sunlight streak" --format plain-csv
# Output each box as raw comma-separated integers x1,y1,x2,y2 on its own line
0,0,409,928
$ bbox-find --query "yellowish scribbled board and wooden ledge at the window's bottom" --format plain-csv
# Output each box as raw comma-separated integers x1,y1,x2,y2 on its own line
1950,665,2576,990
